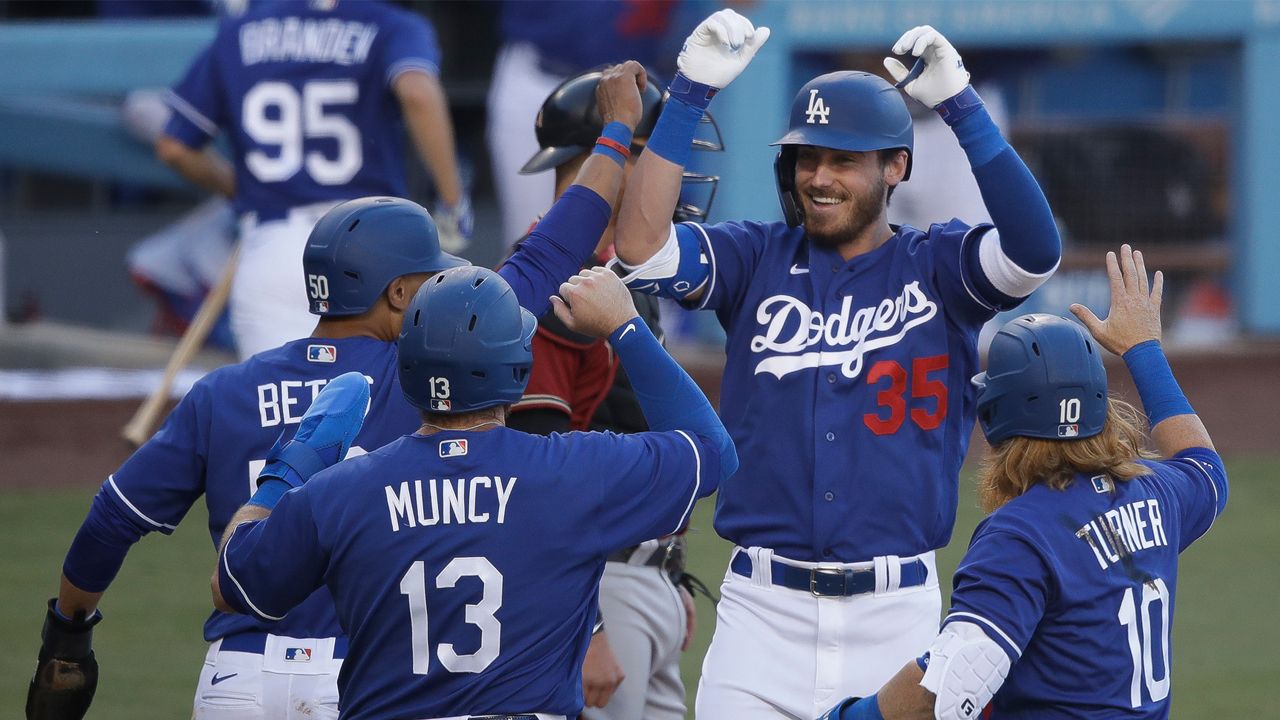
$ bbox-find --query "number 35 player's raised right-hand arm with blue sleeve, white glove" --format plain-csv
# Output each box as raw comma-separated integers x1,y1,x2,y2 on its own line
884,26,1062,310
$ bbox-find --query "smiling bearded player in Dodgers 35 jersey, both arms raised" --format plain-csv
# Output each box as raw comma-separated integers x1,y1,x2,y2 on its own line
614,10,1060,719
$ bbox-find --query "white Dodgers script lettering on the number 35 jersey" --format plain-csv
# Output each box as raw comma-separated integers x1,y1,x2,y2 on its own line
751,281,938,379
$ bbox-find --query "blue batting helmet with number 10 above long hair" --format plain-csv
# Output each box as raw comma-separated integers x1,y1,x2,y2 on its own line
973,314,1108,445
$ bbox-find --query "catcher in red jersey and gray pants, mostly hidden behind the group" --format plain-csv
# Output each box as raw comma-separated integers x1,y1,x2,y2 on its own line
508,64,719,720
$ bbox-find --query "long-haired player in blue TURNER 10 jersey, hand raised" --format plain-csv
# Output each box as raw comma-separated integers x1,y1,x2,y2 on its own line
824,245,1228,720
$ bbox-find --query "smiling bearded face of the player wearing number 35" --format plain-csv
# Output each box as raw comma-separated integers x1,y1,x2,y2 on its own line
795,145,906,247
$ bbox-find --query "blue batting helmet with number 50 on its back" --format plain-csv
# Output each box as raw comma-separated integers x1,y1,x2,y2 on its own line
302,197,470,318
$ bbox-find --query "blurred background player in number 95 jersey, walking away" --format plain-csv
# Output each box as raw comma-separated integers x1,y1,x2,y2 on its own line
155,0,471,357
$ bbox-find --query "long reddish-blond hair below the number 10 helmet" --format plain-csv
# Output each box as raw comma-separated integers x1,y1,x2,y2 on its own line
978,397,1156,512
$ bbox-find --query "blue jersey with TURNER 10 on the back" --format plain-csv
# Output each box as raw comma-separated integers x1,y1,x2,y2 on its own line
943,448,1228,719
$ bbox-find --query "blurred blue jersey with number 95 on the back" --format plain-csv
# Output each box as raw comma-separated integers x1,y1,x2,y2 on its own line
165,0,440,222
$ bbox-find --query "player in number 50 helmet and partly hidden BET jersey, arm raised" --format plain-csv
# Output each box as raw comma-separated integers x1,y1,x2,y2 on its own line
27,63,644,720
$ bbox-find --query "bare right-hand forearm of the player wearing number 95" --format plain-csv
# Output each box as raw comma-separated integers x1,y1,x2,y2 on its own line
393,70,462,205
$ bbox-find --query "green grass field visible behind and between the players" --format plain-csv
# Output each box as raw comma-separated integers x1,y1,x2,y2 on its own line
0,457,1280,720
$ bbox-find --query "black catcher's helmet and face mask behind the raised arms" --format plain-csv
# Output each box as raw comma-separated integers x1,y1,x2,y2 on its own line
520,68,724,223
